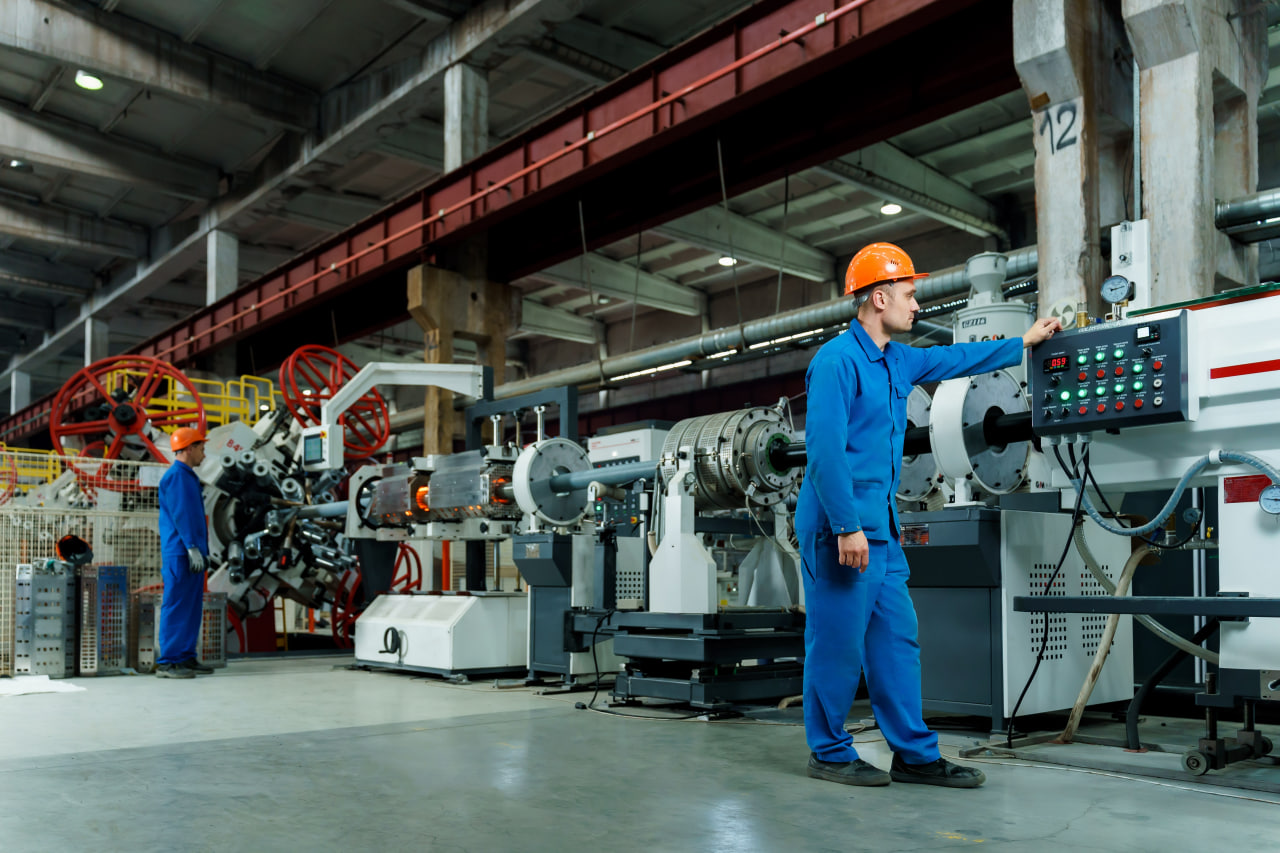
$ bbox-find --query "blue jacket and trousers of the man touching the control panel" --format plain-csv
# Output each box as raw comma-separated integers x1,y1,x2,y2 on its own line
795,320,1023,763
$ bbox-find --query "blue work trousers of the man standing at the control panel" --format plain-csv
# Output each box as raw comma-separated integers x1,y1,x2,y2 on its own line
799,532,938,763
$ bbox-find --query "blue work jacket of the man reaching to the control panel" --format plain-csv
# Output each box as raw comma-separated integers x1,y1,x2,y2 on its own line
795,320,1023,539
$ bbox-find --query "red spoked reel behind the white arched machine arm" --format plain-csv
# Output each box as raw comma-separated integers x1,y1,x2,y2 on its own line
273,343,392,460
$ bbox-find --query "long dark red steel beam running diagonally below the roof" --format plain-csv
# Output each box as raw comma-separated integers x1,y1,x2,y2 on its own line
0,0,1009,441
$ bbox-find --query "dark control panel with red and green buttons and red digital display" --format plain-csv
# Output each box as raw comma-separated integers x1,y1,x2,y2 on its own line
1027,311,1190,435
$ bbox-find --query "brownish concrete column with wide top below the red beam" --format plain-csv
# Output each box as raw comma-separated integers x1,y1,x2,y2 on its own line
408,265,520,453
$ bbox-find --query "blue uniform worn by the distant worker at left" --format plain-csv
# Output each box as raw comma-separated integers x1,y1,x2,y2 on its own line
156,461,209,663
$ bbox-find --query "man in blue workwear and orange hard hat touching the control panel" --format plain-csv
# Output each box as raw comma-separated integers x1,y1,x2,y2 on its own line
795,243,1062,788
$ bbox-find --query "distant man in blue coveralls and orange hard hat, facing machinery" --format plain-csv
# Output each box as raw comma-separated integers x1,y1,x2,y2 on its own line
156,427,214,679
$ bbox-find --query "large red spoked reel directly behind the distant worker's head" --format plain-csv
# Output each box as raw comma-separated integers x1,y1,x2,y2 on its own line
49,355,205,491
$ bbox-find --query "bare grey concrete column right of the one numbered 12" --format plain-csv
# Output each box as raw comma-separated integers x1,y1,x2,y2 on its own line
1123,0,1268,298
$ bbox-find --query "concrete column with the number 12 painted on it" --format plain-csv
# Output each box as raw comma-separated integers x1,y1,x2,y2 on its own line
1014,0,1133,315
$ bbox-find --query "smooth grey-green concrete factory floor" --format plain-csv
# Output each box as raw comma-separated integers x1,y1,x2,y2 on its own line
0,658,1280,853
